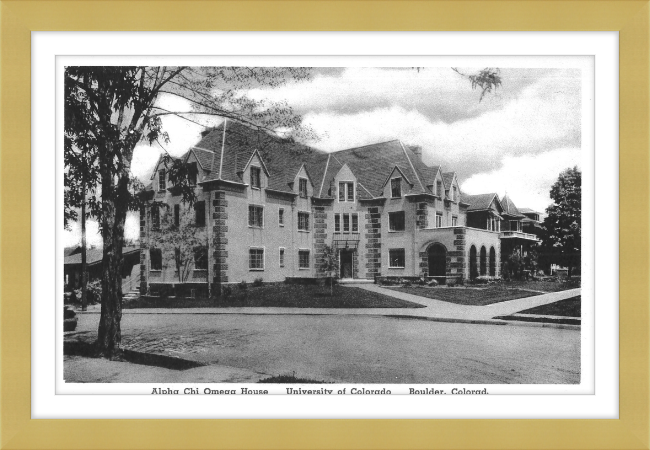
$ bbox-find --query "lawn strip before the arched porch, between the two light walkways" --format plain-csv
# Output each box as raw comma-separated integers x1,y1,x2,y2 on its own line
395,284,540,306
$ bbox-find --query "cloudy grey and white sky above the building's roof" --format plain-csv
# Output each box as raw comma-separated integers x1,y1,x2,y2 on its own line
64,67,581,246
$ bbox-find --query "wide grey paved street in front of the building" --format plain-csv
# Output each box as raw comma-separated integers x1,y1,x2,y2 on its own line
65,314,580,384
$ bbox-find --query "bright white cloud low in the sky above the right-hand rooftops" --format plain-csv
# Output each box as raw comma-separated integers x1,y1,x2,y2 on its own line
461,148,581,213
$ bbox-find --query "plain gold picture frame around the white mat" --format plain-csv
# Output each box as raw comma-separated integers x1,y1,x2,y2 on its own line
0,0,650,449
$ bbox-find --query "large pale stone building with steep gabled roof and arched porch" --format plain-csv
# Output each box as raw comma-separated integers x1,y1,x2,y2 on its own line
140,121,536,293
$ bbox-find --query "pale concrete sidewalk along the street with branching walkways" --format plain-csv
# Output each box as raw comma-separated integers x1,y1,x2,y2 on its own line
77,284,580,329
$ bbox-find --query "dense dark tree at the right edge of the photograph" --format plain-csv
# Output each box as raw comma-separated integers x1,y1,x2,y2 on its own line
541,167,582,277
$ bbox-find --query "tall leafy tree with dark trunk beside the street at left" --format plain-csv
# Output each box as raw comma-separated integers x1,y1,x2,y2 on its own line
64,66,310,357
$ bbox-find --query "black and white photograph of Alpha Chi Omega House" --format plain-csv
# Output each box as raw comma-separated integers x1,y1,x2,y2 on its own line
62,61,593,395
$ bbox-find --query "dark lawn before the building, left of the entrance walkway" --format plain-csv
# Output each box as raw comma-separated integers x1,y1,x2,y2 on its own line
123,284,424,309
